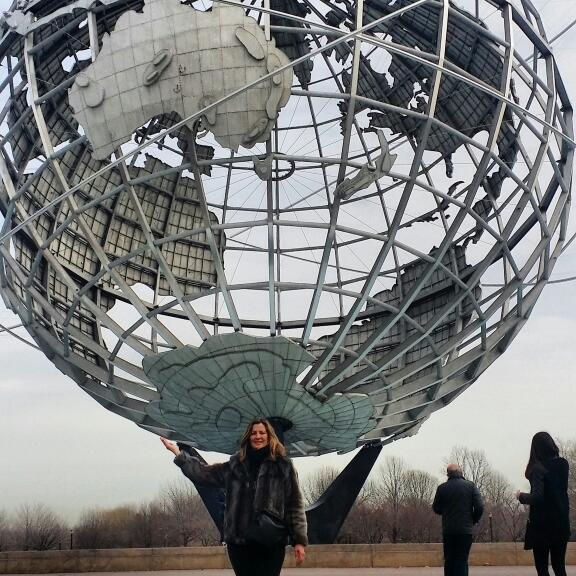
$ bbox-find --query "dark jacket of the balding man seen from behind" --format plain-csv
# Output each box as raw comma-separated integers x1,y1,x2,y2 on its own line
432,474,484,534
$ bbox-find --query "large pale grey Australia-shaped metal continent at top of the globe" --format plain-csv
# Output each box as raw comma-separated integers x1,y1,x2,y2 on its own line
69,0,293,160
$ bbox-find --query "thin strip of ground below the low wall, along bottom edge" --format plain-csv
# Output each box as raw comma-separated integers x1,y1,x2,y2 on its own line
4,566,576,576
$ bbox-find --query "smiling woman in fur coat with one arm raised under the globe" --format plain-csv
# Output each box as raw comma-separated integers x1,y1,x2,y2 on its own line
161,419,308,576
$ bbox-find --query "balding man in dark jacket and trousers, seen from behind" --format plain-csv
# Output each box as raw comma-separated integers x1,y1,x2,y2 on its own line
432,464,484,576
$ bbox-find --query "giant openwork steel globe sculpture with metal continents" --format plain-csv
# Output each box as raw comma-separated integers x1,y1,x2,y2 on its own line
0,0,574,456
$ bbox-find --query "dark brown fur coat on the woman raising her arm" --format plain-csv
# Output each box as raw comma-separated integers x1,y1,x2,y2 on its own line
174,451,308,546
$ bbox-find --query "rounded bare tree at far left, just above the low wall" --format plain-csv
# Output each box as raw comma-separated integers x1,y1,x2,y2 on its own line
14,504,67,550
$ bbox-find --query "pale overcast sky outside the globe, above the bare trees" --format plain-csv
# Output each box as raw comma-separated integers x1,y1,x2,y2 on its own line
0,0,576,520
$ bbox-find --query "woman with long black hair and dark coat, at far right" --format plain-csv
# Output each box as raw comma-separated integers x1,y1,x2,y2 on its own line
516,432,570,576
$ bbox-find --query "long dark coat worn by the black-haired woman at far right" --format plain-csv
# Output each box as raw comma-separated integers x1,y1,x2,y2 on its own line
519,458,570,550
